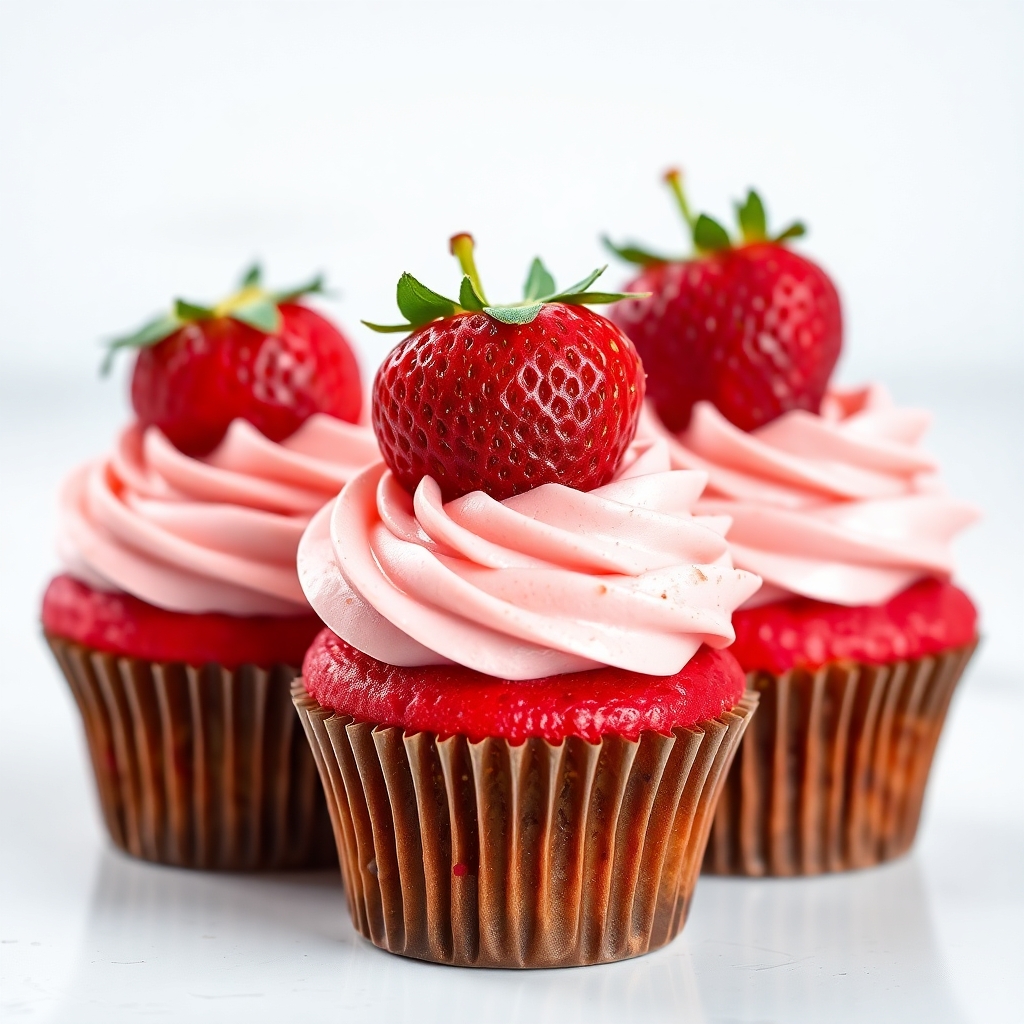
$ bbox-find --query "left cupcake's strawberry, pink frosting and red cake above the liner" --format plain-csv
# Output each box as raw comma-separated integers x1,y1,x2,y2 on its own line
43,267,379,664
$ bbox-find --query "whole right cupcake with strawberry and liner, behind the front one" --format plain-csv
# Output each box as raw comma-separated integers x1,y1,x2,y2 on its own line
602,174,977,876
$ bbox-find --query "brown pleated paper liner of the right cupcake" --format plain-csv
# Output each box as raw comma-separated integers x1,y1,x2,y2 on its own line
703,641,977,876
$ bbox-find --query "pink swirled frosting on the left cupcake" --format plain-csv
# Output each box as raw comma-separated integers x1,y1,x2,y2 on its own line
58,414,380,615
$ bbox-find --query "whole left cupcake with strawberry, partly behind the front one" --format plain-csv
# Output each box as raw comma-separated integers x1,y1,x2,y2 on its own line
42,270,379,868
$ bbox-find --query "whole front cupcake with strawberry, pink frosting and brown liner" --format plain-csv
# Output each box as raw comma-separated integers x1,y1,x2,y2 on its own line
294,236,760,968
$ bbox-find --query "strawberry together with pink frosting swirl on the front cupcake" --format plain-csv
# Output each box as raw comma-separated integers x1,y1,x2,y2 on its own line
298,236,760,733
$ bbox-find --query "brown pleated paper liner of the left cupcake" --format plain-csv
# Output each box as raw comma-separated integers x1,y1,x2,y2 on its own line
47,636,337,870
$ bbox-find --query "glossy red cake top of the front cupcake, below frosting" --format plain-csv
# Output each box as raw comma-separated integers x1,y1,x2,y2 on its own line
302,629,744,743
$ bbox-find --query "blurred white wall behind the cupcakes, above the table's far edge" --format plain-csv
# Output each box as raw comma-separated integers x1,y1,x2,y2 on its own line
0,0,1024,382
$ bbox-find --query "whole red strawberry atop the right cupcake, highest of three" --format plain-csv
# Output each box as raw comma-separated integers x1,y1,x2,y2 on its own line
605,171,843,431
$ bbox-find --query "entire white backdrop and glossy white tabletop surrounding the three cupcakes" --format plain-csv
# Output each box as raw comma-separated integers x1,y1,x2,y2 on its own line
0,0,1024,1024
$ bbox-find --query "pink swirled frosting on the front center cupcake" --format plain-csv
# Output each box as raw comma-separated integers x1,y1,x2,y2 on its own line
298,441,760,679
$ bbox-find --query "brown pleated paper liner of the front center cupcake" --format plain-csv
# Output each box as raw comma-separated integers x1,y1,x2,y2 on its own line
292,679,757,968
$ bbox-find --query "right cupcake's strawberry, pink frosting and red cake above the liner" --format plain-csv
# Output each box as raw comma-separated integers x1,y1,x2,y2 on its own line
612,171,978,671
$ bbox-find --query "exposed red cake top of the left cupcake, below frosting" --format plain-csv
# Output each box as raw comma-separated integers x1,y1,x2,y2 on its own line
42,575,323,669
